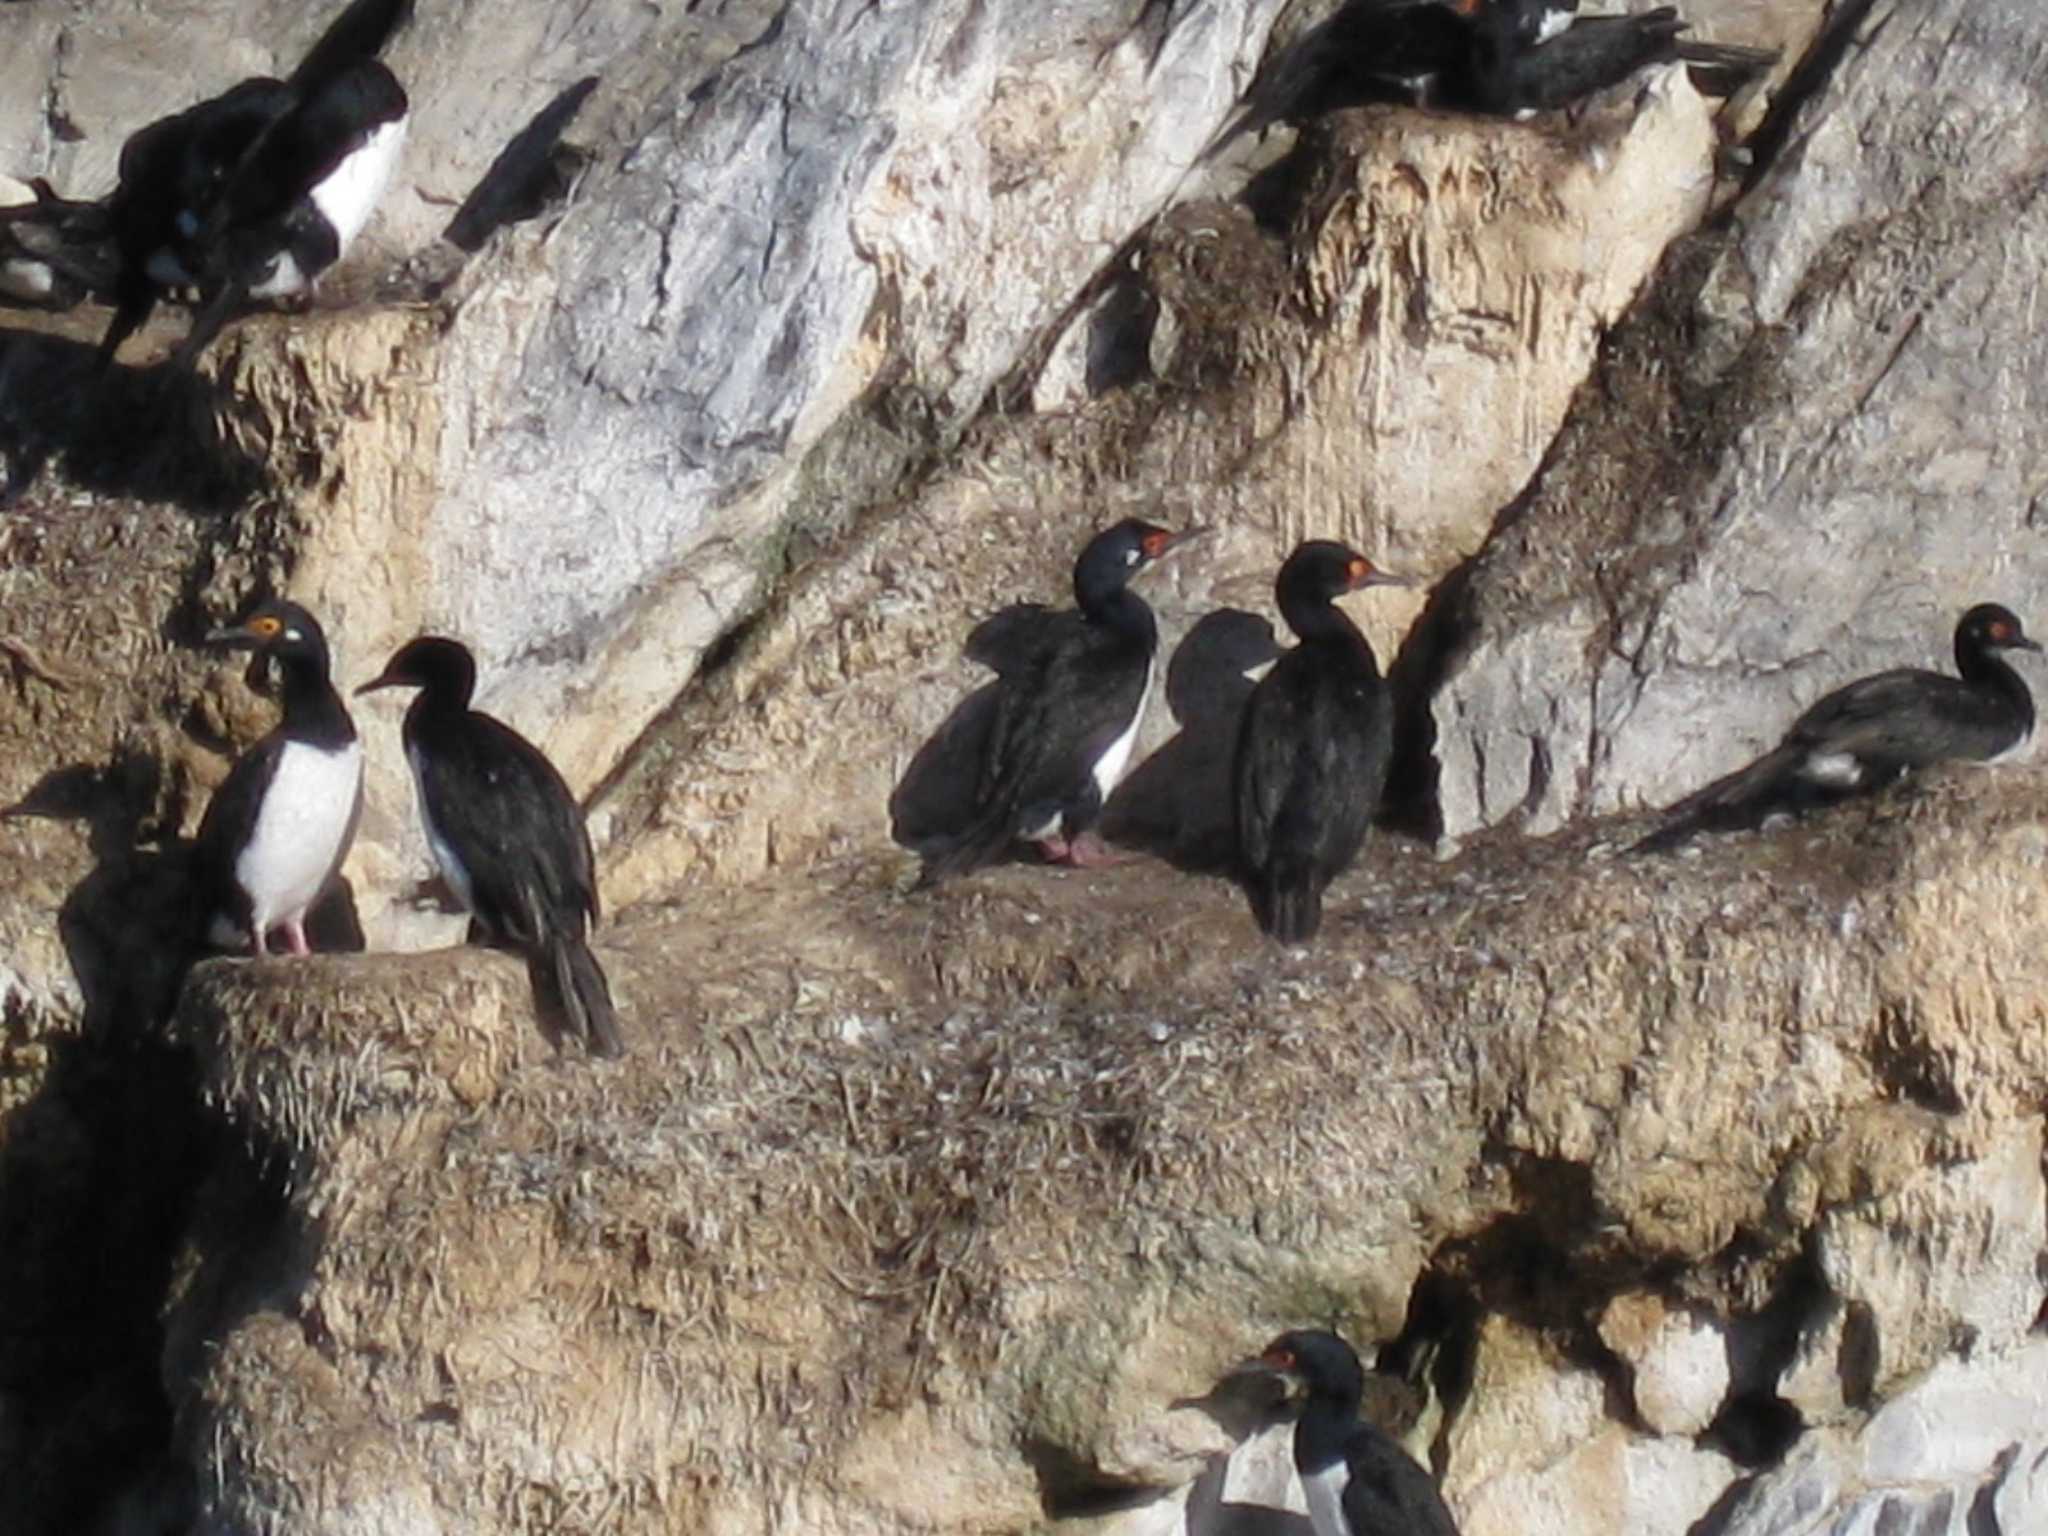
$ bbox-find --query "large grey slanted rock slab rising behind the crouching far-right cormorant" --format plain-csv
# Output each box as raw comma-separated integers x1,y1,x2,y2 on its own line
1436,0,2048,838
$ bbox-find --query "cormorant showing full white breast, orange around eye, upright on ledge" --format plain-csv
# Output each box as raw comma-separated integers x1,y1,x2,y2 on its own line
193,602,362,954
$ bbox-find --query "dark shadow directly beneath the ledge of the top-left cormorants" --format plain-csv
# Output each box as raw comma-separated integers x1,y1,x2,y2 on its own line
0,326,266,516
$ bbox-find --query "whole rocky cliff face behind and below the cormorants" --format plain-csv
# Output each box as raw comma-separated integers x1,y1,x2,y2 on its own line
0,0,2048,1536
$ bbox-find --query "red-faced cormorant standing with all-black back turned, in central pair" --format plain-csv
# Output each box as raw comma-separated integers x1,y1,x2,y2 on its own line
1233,539,1405,944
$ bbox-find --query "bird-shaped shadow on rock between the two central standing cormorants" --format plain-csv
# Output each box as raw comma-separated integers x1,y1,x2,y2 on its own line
1102,608,1280,874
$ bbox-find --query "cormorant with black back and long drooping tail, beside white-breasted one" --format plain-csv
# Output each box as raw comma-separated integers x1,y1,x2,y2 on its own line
356,635,625,1057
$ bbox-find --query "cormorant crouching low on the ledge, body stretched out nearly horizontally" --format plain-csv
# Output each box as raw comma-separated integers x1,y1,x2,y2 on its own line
1632,602,2040,854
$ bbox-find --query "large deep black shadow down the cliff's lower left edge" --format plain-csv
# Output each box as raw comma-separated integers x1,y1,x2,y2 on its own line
0,754,362,1532
